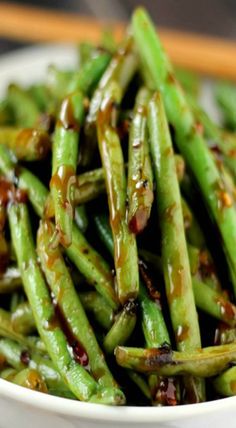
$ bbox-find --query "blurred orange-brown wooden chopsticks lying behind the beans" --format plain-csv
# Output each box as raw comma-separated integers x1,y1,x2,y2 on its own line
0,2,236,81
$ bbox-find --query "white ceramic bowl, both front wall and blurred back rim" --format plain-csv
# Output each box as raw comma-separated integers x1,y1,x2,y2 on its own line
0,45,236,428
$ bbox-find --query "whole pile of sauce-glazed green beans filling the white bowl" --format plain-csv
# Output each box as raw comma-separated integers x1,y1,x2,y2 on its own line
0,8,236,406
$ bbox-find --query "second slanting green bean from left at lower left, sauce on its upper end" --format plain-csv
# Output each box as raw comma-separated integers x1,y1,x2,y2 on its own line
37,221,118,387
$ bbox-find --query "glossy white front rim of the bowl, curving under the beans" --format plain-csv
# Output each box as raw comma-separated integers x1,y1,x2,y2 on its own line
0,379,236,424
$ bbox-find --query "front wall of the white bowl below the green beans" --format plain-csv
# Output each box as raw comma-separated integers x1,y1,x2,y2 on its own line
0,380,236,428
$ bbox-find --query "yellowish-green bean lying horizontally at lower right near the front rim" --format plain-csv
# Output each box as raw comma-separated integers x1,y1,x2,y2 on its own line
115,344,236,377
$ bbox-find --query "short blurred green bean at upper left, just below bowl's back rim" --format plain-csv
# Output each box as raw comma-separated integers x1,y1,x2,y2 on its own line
7,84,40,128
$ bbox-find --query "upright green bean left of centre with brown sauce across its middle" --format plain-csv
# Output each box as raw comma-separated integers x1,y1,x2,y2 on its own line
50,92,84,247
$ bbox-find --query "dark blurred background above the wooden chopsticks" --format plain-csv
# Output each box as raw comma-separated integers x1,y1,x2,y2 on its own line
0,0,236,54
